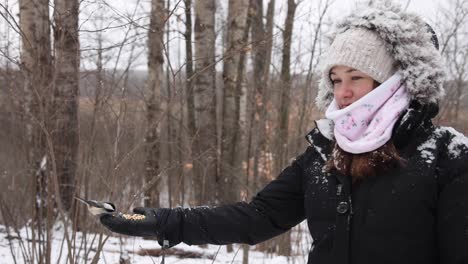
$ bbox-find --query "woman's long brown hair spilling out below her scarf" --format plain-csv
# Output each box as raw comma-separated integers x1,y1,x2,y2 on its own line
325,141,405,183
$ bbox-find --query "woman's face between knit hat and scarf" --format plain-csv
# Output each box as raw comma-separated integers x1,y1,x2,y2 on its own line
330,65,376,109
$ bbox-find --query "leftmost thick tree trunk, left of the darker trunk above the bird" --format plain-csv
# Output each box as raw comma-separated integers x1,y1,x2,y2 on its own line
19,0,52,208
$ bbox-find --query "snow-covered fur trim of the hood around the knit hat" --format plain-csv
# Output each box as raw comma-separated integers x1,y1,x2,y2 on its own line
316,0,445,112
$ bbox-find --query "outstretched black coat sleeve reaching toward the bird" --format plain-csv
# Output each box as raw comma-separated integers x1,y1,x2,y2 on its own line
157,151,305,246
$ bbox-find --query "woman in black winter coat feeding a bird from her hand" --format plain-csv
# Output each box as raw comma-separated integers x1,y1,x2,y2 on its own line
101,1,468,264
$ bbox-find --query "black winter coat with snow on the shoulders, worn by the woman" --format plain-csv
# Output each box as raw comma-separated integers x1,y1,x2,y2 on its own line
157,103,468,264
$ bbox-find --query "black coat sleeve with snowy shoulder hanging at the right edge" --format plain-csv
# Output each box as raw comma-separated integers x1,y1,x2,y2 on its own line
437,129,468,264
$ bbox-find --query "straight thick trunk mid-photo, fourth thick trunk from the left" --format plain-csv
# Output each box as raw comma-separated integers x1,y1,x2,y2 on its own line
193,0,218,204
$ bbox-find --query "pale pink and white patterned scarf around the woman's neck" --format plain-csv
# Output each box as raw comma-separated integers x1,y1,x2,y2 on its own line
325,74,410,154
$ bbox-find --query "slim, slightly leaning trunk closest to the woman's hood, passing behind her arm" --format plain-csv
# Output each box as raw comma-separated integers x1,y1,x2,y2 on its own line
275,0,297,256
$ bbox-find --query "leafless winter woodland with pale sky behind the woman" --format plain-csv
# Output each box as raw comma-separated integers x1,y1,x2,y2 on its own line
0,0,468,263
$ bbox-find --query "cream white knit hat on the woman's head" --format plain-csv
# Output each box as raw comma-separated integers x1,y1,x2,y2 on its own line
322,28,396,89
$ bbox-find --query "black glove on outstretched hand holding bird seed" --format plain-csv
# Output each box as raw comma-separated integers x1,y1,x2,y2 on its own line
100,207,158,237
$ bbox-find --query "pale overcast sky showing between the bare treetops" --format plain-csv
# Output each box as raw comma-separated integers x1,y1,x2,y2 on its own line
0,0,450,71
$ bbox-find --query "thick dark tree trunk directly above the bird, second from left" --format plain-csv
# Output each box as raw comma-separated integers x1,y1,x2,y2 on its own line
52,0,80,211
